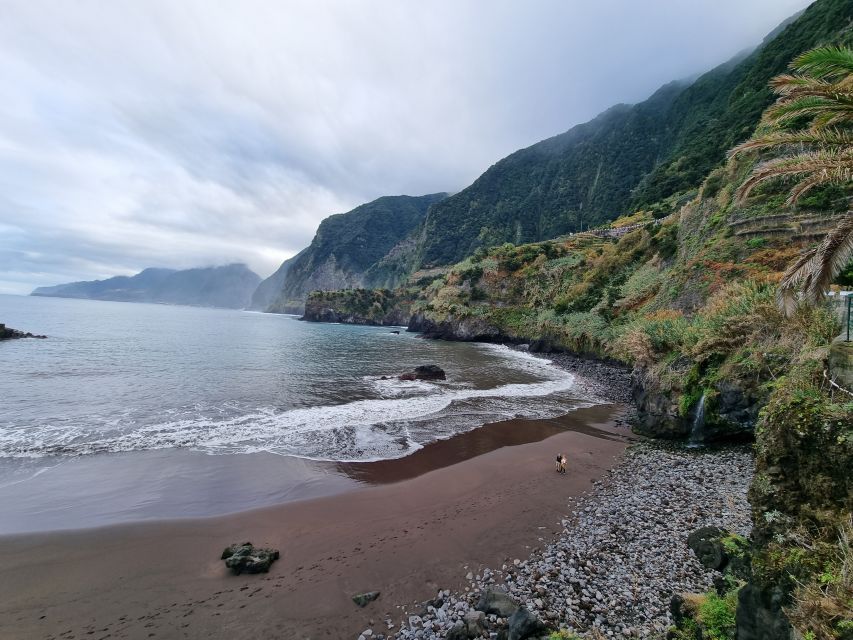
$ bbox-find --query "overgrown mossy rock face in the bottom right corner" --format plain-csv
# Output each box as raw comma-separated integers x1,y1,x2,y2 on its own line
737,361,853,640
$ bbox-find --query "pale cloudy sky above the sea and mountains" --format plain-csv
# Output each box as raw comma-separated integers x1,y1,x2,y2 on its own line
0,0,809,294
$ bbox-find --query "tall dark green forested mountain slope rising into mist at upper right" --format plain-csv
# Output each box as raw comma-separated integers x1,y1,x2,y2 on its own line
417,0,853,267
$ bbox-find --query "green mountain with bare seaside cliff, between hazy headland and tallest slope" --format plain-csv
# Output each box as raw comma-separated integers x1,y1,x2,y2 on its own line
264,193,447,313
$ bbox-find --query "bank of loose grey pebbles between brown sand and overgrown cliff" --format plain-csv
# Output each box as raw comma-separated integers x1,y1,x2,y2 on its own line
372,443,753,640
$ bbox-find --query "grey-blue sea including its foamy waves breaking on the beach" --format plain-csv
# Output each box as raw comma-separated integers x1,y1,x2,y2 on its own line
0,295,578,532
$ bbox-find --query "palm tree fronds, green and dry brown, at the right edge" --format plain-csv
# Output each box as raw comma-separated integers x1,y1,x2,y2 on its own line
729,47,853,314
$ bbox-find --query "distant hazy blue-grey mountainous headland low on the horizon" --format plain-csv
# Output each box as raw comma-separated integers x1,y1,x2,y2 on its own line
30,264,261,309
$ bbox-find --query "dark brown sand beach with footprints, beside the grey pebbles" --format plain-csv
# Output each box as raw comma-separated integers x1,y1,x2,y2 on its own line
0,405,626,640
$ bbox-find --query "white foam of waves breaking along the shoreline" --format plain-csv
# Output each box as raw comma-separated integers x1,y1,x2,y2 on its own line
0,345,574,461
